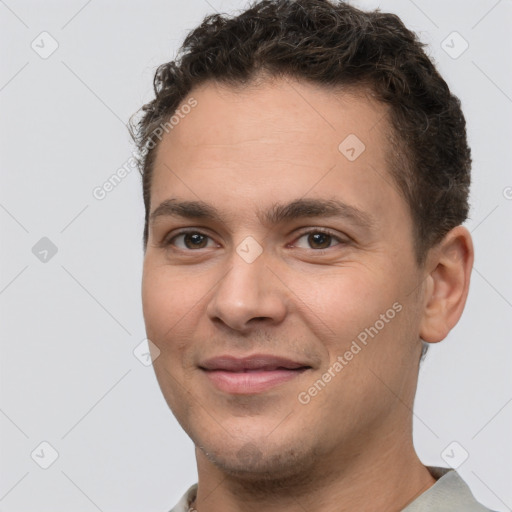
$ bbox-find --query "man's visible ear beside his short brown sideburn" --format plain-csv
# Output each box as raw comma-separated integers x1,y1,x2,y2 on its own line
420,226,474,343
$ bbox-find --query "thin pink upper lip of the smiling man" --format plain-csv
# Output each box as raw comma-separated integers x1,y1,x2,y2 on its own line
199,354,311,372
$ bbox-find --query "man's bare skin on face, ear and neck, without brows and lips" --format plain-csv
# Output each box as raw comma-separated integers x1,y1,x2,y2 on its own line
142,78,473,512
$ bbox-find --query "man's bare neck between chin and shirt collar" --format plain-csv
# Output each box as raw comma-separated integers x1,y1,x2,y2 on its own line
193,431,435,512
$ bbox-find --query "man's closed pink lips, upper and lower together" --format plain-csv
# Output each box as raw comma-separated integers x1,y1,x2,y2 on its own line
199,354,311,395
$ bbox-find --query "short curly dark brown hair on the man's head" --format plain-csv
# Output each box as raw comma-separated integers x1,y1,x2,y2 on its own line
130,0,471,263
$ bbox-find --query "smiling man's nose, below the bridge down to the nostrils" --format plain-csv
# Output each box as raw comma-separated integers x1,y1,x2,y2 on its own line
207,248,287,332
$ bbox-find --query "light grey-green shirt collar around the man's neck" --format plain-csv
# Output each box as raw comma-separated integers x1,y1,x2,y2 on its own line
171,467,492,512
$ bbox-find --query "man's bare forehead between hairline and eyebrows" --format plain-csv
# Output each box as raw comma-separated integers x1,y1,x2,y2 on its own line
151,79,400,225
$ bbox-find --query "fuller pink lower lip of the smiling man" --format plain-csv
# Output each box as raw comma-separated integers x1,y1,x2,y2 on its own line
205,368,306,395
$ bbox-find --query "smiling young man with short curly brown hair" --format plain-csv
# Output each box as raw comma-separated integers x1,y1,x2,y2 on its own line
130,0,494,512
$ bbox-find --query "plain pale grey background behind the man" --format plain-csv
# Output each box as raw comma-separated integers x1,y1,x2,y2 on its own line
0,0,512,512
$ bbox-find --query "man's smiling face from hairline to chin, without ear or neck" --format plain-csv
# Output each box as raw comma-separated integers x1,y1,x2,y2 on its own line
142,80,423,477
